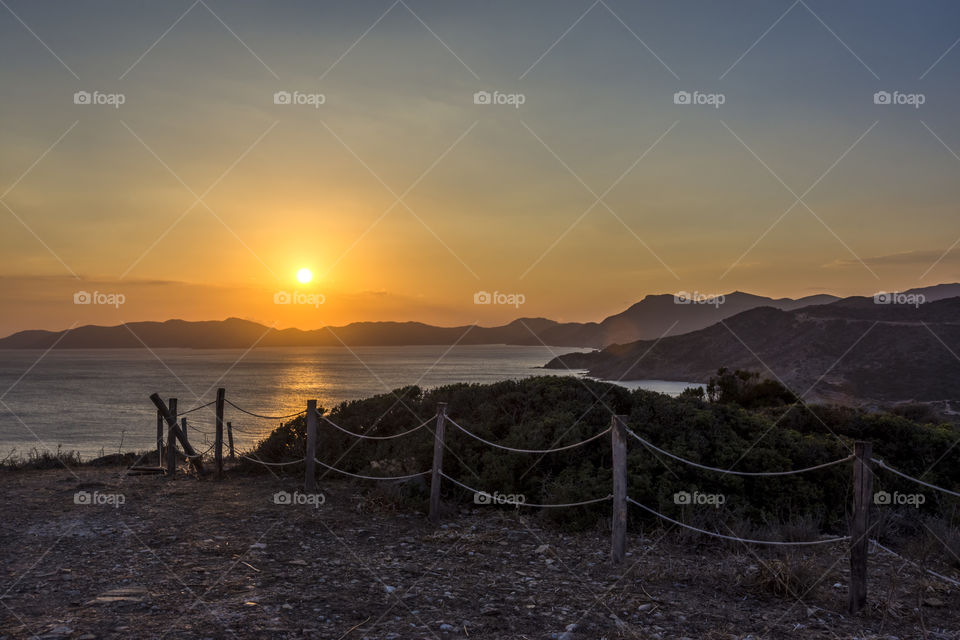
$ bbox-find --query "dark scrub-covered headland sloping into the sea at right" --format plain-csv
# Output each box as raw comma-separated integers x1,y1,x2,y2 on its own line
547,297,960,401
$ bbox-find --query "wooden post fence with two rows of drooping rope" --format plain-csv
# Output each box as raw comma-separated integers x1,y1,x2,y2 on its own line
137,388,960,613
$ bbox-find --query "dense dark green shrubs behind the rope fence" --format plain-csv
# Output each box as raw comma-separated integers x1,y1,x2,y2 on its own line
244,370,960,533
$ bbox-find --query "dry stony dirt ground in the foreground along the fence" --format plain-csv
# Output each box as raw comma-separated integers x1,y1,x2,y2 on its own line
0,468,960,640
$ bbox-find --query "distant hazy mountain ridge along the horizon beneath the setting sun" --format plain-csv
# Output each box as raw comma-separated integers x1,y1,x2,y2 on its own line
0,284,960,358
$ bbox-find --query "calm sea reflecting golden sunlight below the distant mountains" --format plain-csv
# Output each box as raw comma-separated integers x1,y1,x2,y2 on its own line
0,345,700,459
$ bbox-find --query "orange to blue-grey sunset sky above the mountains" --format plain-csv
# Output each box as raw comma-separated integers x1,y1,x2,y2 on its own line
0,0,960,335
